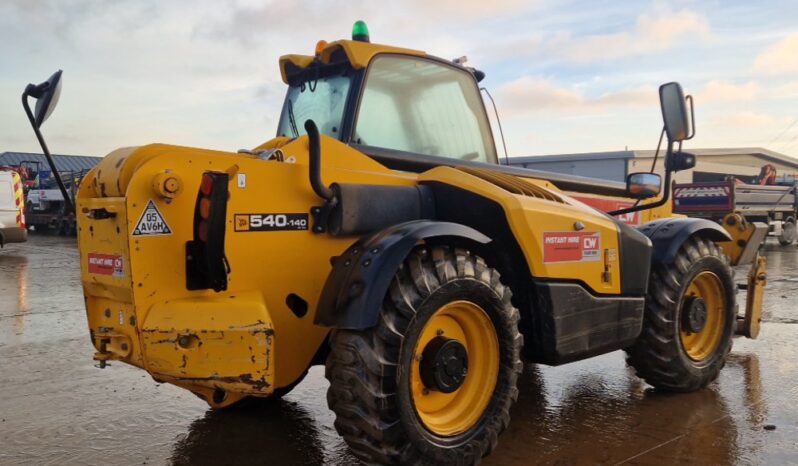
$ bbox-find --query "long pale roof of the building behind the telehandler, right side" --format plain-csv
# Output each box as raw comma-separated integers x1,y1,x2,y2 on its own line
510,147,798,169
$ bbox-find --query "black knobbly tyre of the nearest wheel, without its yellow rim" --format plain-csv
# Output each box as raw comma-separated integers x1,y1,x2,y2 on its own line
325,246,523,465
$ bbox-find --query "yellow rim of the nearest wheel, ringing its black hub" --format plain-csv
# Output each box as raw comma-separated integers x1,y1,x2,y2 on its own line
410,301,499,436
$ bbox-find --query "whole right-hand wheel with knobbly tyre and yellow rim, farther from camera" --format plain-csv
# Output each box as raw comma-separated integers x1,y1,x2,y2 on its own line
626,237,736,392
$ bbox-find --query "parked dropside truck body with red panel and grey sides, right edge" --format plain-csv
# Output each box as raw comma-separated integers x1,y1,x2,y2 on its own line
673,180,798,246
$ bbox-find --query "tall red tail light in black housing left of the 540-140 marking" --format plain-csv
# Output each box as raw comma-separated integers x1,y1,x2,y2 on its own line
186,172,230,292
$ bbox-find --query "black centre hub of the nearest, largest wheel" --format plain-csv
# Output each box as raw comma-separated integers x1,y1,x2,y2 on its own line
419,336,468,393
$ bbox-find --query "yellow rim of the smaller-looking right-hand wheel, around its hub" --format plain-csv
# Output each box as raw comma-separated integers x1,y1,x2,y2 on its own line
679,271,726,362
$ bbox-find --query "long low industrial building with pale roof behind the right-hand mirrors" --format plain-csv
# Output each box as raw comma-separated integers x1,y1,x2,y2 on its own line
510,147,798,183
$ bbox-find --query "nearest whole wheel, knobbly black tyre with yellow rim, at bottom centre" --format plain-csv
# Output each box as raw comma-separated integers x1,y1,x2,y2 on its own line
326,246,523,465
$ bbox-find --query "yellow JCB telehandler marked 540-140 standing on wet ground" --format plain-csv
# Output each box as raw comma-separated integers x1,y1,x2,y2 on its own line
23,22,768,464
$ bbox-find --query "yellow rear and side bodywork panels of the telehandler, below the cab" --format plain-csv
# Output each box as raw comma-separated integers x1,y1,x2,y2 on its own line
78,137,620,406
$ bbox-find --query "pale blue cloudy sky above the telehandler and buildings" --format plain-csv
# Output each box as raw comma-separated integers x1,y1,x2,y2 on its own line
0,0,798,156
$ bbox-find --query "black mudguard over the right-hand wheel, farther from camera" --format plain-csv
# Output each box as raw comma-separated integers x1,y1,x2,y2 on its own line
638,218,732,264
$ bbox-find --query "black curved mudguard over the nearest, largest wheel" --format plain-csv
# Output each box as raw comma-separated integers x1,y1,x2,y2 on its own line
314,220,491,330
